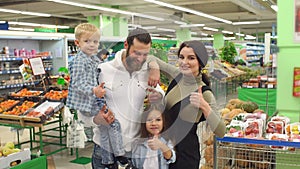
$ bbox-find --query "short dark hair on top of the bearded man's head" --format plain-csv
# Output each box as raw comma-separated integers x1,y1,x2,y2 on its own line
126,28,152,48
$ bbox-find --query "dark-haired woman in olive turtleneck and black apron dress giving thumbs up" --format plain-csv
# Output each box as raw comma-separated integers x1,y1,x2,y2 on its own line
151,41,225,169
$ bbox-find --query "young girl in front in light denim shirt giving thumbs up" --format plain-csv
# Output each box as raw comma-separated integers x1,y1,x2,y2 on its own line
132,104,176,169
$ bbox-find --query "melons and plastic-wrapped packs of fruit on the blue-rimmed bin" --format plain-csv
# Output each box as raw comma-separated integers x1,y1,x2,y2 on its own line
221,99,300,150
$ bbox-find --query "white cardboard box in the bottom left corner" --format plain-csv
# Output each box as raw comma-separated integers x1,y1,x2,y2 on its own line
0,149,31,169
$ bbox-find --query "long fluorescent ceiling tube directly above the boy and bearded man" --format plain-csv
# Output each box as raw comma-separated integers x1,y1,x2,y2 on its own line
48,0,164,21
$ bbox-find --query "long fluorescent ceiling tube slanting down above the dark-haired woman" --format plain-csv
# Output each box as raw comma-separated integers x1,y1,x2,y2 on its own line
144,0,232,24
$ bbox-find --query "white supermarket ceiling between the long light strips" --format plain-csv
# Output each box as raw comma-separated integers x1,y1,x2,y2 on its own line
0,0,277,39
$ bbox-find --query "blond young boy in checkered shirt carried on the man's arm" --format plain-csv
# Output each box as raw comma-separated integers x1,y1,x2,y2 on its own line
66,23,128,168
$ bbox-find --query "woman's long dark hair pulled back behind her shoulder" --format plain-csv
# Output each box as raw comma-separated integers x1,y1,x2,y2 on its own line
177,41,210,86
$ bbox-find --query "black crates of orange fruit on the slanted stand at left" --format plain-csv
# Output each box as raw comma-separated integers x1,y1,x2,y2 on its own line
0,88,68,123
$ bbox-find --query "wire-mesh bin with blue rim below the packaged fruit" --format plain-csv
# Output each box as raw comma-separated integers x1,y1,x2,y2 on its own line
213,138,300,169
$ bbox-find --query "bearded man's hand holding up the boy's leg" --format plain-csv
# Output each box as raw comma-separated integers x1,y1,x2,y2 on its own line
94,105,115,125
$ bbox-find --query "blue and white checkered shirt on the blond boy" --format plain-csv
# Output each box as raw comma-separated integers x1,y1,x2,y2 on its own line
66,51,105,115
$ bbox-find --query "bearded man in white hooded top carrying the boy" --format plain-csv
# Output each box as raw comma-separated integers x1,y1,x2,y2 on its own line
78,28,163,169
